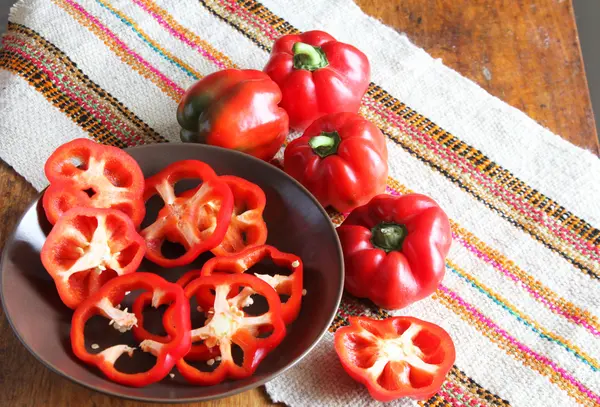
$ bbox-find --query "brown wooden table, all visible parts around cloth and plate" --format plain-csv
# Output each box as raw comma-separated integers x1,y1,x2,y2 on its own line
0,0,600,407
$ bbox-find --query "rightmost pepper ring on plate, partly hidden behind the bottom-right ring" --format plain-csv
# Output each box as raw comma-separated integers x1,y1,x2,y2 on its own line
202,245,303,324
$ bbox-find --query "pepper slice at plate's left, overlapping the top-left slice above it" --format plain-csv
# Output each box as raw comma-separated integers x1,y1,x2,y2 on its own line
41,207,146,308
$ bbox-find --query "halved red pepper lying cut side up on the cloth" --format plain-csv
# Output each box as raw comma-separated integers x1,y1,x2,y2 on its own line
335,317,456,402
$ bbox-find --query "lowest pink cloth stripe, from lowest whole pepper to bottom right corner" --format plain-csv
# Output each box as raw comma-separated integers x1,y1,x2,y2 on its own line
438,285,600,404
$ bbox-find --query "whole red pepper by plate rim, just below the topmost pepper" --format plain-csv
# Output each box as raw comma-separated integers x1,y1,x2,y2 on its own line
283,113,388,212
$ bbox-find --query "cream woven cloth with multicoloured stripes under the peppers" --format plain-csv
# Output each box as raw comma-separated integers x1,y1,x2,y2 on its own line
0,0,600,407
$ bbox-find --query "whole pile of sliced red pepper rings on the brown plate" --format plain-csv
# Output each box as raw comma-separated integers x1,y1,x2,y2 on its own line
41,139,303,387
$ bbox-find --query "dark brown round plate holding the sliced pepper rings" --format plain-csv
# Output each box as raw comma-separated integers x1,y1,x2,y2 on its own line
0,144,344,402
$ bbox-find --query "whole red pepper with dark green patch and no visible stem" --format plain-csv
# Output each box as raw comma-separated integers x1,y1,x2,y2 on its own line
177,69,288,161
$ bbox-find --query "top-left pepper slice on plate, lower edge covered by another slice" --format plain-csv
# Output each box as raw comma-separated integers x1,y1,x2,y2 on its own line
43,138,146,227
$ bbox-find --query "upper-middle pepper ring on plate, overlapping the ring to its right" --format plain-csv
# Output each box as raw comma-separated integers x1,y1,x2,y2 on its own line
140,160,233,267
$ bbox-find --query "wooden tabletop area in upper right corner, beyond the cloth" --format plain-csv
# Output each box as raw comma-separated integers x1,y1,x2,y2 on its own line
356,0,600,154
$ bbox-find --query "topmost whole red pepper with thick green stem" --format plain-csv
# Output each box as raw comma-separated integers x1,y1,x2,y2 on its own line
264,31,371,131
